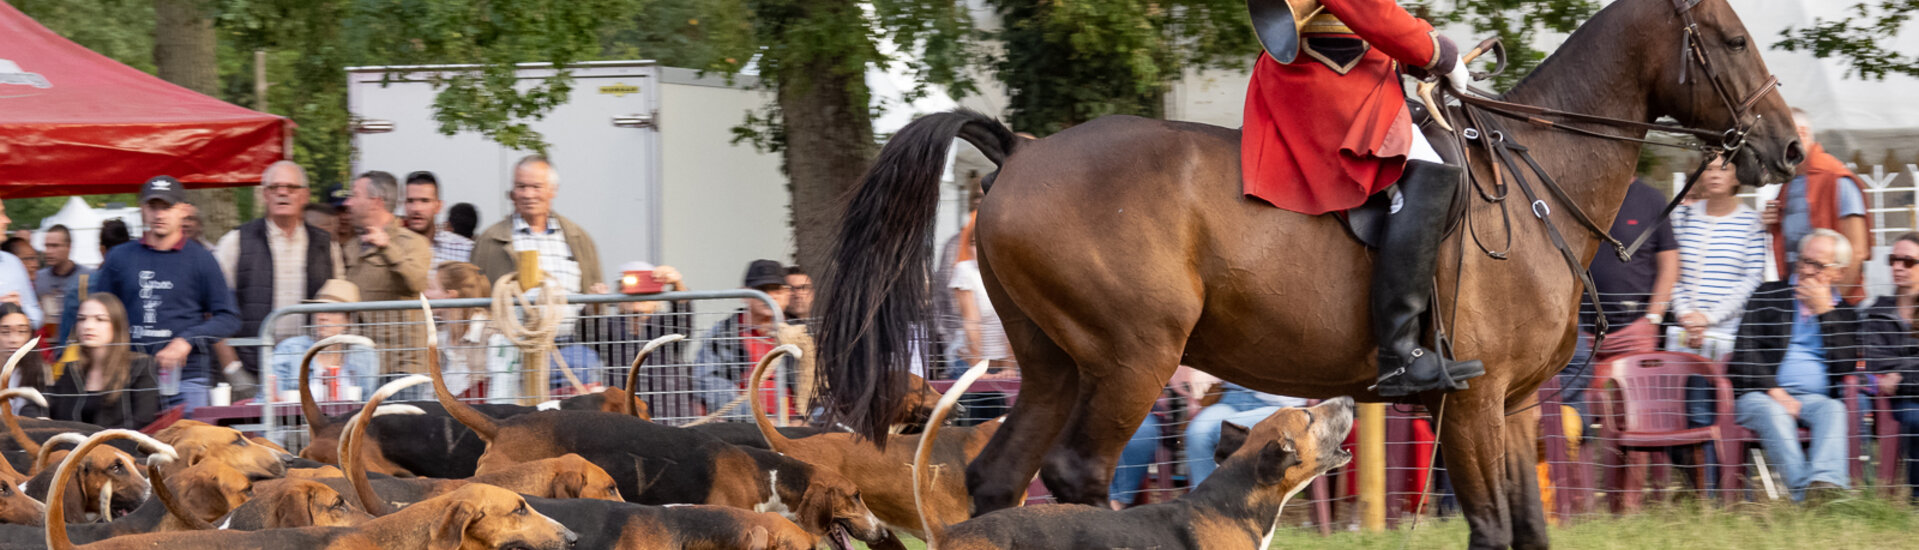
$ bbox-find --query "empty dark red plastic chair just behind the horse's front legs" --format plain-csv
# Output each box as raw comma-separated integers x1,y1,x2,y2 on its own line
1591,351,1737,512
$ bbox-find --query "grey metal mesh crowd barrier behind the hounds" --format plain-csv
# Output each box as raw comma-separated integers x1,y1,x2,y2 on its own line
239,289,794,448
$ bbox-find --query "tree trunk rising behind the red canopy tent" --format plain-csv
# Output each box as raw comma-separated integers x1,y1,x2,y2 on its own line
154,0,240,240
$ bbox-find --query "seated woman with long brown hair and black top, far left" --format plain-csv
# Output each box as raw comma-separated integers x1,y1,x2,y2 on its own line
46,293,159,429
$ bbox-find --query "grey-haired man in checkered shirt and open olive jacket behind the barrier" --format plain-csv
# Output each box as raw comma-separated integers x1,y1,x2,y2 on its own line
472,155,608,339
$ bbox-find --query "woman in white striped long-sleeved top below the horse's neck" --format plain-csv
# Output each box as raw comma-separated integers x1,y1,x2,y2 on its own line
1671,157,1765,358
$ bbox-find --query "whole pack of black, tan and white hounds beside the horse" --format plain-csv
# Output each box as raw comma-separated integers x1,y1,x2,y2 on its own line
0,303,1353,550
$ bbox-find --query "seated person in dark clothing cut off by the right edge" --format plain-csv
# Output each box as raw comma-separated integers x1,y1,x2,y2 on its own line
1860,232,1919,500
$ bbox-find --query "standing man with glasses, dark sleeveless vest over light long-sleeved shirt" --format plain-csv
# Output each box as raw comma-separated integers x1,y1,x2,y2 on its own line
213,161,344,376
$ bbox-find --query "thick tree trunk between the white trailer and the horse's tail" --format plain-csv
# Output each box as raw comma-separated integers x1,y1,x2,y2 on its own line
777,55,875,270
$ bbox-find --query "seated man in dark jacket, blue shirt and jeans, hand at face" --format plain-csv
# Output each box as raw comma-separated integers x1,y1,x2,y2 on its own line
1727,228,1860,500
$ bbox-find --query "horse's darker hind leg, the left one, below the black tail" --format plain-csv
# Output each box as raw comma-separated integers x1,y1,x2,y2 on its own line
965,312,1078,516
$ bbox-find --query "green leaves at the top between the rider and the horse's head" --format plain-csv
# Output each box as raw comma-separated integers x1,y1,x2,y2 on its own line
1418,0,1599,90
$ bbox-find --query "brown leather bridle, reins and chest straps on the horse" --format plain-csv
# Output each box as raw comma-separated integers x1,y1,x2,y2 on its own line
1420,0,1779,414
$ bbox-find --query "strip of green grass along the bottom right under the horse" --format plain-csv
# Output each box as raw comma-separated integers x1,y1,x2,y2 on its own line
875,498,1919,550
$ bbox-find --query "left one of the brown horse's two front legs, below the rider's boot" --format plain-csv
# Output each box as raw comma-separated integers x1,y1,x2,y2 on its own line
1426,390,1537,550
